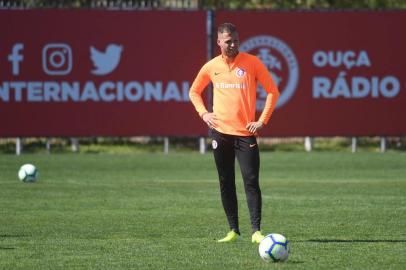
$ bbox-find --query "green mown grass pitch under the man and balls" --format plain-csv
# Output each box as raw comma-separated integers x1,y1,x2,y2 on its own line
0,152,406,269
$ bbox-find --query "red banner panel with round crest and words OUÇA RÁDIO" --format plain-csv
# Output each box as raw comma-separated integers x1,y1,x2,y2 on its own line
216,11,406,136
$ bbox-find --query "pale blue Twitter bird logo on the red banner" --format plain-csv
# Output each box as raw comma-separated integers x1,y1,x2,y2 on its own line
90,44,123,76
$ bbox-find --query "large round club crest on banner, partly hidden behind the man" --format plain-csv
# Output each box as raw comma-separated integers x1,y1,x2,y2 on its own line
240,35,299,111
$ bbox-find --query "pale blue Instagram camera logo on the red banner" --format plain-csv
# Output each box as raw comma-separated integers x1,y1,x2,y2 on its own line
42,43,72,75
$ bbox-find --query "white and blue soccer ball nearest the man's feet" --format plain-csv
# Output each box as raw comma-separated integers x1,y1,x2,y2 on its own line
259,233,290,262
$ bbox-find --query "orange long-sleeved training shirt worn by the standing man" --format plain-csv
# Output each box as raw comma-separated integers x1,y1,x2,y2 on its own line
189,52,279,136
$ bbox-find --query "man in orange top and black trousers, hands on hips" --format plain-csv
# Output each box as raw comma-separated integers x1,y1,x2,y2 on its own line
189,23,279,243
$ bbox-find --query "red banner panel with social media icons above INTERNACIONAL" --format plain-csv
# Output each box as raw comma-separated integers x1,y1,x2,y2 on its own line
0,10,207,137
